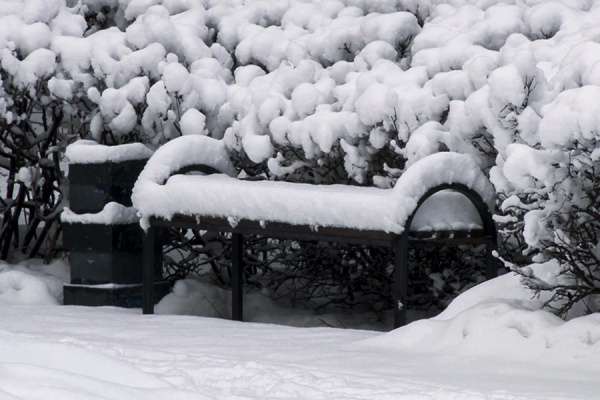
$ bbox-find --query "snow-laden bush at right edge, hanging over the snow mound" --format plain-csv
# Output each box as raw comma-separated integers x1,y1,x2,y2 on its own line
492,85,600,315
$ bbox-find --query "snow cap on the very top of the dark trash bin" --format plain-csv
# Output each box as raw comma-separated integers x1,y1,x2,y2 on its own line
65,140,154,164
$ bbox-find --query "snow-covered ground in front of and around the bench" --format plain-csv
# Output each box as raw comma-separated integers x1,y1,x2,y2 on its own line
0,261,600,400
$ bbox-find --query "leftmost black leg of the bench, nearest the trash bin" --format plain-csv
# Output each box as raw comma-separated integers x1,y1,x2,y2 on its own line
142,226,162,314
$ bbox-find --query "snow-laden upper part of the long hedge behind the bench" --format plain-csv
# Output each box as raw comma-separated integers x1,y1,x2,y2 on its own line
0,0,600,316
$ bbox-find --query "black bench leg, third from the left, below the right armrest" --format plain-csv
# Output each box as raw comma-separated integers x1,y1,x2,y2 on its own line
394,234,408,329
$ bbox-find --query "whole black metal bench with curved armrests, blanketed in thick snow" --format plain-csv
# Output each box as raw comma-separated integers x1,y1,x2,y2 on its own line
132,136,497,327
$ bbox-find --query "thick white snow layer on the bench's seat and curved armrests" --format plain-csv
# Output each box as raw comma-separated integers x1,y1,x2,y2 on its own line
132,136,493,233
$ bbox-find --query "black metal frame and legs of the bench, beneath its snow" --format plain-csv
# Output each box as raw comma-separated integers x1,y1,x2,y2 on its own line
143,183,498,328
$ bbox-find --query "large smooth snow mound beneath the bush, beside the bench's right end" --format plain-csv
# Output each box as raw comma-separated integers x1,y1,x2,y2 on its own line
365,263,600,362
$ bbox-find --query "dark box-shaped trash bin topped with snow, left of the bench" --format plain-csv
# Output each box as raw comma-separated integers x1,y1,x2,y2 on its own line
63,141,170,308
